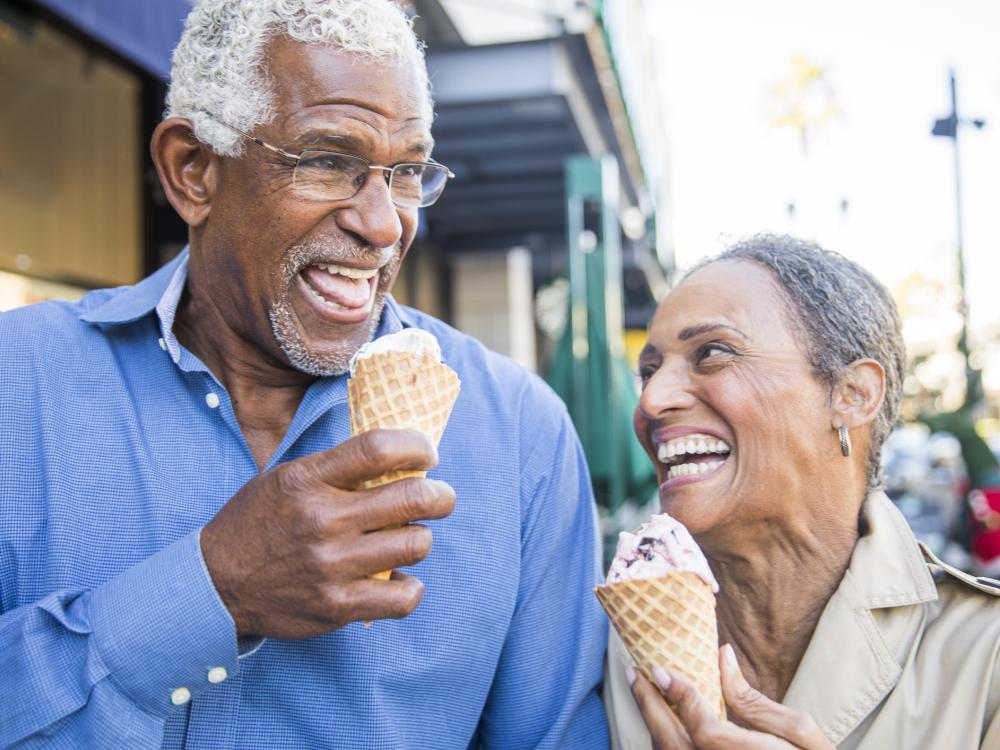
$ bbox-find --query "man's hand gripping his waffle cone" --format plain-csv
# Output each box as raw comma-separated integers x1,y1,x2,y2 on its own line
201,430,455,638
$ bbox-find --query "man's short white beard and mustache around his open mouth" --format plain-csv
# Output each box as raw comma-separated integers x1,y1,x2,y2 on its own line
268,240,402,377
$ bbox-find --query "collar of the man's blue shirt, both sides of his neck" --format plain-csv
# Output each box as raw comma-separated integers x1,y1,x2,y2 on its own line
80,246,416,364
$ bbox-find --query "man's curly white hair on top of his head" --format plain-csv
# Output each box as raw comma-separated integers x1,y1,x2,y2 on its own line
166,0,431,156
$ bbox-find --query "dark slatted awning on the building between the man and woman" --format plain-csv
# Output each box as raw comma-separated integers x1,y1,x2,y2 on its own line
427,35,639,261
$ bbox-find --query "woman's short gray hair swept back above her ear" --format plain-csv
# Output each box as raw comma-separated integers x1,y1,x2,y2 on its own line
692,234,906,490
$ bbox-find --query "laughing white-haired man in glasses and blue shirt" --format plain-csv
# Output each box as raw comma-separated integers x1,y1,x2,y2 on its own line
0,0,607,749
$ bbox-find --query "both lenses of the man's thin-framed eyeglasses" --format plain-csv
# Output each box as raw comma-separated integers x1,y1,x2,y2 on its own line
292,151,448,208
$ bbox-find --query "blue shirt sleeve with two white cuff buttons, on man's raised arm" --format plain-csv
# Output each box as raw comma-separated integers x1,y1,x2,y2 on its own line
0,531,237,750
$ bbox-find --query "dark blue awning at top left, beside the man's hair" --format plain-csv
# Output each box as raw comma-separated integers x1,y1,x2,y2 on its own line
35,0,191,79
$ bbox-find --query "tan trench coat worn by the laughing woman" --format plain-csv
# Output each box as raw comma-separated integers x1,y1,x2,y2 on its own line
604,493,1000,750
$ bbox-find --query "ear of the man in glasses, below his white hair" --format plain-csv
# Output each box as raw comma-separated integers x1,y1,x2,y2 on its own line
150,117,218,227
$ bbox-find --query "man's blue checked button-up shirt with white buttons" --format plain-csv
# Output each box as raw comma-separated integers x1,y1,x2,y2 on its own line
0,253,608,750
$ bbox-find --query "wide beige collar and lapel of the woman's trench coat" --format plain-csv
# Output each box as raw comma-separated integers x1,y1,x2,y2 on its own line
784,492,937,744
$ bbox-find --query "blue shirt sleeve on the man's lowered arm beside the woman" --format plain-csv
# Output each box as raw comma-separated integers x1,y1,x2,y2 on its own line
478,390,608,750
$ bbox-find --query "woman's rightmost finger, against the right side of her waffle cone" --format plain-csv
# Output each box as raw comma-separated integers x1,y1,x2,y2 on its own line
719,644,834,750
